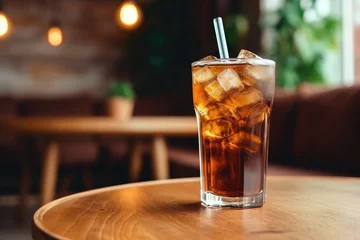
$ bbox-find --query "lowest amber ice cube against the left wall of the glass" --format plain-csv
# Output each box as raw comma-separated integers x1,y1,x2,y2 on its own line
203,118,235,139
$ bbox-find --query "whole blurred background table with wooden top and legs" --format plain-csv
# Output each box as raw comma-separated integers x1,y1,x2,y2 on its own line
0,116,198,205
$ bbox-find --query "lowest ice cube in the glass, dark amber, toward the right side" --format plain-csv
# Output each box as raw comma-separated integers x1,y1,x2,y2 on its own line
229,131,261,153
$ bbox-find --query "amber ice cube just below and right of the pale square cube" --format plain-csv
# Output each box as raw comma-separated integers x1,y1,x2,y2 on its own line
225,87,263,108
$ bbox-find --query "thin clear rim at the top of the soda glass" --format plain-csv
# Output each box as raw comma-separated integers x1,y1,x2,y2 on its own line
191,58,276,67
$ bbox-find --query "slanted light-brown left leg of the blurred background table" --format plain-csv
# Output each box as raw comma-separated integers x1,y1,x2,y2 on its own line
40,141,59,206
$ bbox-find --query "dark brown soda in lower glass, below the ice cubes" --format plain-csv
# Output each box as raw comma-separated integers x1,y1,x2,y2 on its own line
200,102,269,197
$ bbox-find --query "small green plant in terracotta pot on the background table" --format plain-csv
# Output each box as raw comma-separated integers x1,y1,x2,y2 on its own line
107,81,135,120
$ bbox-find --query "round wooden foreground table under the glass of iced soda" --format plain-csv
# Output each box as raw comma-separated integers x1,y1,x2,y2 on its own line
32,177,360,240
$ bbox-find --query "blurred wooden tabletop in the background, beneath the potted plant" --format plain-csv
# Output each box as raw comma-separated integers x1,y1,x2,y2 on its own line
0,116,197,136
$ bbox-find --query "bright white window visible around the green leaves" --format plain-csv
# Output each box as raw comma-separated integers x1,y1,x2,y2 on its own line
261,0,360,86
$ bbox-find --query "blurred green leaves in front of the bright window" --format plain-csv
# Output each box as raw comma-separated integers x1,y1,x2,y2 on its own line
260,0,340,88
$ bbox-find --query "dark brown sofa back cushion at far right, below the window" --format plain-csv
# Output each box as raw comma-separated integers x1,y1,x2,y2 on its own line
293,86,360,175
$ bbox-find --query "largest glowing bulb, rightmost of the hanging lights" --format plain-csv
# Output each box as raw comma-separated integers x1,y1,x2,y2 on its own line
116,1,141,29
